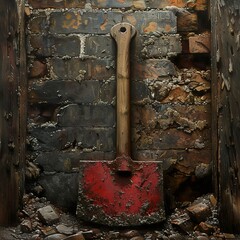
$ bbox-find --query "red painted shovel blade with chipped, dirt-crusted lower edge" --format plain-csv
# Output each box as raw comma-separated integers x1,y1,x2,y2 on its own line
77,160,165,226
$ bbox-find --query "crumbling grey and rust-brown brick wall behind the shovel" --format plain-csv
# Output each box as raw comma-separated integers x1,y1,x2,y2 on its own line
26,0,211,208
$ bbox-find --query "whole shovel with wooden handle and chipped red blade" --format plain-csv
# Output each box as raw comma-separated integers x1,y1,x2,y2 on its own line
77,23,165,226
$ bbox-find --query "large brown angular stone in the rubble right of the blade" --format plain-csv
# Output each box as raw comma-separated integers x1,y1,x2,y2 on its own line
187,203,211,223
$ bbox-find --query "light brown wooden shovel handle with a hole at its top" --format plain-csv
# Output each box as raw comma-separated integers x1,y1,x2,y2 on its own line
111,23,136,156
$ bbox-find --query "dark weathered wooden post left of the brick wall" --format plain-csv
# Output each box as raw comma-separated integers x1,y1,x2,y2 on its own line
0,0,25,225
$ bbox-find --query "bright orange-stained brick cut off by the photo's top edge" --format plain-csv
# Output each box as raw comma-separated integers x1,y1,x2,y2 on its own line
147,0,207,11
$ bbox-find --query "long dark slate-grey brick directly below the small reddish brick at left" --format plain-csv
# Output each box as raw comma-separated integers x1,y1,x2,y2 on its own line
28,80,99,104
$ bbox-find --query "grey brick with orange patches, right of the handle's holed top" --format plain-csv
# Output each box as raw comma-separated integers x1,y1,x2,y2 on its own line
123,11,177,34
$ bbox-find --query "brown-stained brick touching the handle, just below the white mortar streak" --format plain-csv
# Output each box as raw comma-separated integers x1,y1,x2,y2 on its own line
50,58,115,81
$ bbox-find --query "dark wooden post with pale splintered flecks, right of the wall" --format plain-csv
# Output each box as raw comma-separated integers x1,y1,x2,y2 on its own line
211,0,240,233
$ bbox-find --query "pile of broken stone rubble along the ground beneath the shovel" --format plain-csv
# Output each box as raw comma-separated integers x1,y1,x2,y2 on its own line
0,193,240,240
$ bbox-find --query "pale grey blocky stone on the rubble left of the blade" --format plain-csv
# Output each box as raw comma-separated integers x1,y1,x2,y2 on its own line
37,205,60,225
